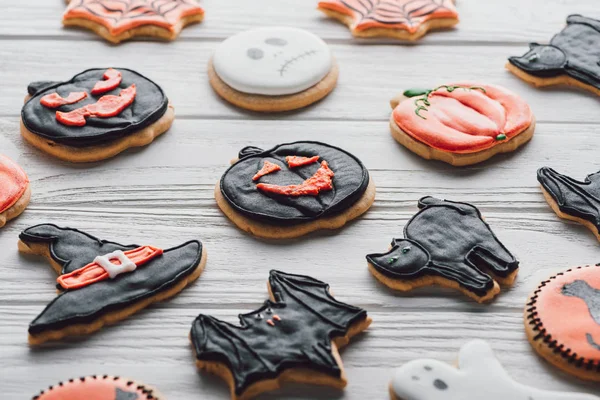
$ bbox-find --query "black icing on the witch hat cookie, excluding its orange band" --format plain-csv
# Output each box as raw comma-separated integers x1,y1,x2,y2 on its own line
19,224,202,335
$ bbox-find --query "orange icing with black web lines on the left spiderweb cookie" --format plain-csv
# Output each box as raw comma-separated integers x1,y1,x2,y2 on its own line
63,0,204,36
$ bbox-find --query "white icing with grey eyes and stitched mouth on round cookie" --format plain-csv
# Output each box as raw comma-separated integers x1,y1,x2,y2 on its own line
213,27,332,96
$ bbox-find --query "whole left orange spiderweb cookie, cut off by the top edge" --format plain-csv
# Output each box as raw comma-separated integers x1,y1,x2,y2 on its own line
63,0,204,43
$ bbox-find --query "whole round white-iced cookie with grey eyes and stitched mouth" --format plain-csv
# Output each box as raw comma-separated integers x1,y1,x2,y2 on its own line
208,27,338,112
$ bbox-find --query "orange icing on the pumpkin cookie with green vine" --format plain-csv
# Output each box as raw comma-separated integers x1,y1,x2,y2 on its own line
393,82,533,153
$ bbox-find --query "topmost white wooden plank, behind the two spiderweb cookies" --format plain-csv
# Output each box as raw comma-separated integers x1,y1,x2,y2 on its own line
0,0,600,45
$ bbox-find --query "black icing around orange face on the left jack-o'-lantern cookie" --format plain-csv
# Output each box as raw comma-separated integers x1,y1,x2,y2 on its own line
21,68,168,147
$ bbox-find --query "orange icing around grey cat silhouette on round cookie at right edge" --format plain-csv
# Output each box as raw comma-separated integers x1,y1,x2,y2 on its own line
536,266,600,364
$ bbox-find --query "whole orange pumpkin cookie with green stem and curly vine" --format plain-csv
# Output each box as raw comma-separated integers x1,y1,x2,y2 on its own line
390,83,535,166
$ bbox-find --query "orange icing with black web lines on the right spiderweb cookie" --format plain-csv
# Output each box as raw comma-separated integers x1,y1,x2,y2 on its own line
319,0,458,33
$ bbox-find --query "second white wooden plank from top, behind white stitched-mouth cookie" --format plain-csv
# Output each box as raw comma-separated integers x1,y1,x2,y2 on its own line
0,40,600,123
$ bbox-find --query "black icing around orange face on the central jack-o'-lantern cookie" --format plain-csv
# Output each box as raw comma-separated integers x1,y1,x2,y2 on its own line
221,141,369,224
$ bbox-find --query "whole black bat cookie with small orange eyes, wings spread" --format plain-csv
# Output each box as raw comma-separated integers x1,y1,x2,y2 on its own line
190,271,371,400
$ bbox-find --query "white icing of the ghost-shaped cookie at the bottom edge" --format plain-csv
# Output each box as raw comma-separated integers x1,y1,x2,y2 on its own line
392,340,600,400
